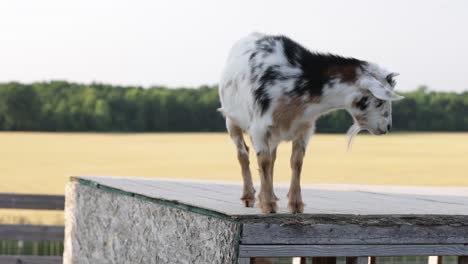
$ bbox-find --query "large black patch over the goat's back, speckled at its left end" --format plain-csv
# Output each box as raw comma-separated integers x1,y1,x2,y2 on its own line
249,36,366,114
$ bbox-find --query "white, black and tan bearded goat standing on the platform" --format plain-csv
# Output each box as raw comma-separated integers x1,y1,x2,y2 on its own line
219,33,403,213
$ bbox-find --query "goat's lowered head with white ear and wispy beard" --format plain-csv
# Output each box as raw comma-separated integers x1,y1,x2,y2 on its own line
348,66,403,142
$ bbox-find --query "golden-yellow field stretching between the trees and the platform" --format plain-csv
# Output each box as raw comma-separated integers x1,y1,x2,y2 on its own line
0,133,468,223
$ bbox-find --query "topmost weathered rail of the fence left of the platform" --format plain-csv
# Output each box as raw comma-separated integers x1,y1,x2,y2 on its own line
0,193,65,210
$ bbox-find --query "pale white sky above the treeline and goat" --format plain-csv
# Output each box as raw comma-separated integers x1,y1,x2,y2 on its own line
0,0,468,91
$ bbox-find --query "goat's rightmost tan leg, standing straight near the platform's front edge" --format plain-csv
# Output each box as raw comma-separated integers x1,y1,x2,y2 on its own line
288,140,306,214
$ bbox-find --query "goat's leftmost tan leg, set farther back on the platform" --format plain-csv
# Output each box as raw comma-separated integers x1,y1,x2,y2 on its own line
226,118,255,207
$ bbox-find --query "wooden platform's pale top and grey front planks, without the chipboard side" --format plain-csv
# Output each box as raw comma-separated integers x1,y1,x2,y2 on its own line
65,176,468,263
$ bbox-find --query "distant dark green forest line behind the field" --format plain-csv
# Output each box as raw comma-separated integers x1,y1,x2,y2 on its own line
0,81,468,133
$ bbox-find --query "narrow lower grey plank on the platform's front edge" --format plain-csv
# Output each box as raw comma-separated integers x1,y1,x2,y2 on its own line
239,244,468,257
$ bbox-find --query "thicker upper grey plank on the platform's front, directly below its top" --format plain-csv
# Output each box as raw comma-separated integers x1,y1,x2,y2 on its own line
242,223,468,245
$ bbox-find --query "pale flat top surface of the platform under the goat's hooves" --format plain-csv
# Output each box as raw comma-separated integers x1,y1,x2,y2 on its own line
78,177,468,218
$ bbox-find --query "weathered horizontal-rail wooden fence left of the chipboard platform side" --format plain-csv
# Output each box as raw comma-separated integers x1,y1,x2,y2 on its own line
0,193,65,264
